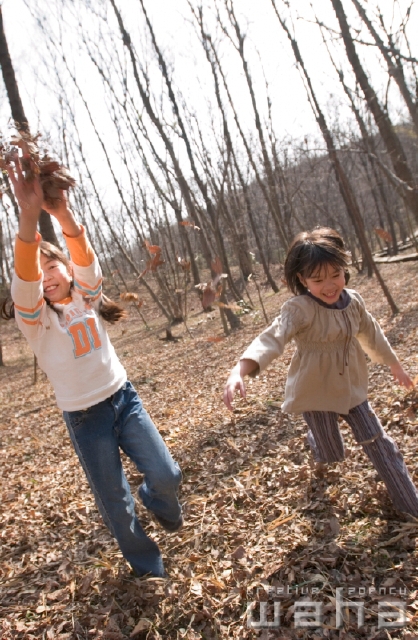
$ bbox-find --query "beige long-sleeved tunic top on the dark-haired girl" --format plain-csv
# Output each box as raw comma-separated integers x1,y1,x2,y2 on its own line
241,289,398,415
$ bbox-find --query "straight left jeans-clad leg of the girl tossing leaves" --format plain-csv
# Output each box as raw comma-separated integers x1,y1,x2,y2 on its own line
64,392,165,576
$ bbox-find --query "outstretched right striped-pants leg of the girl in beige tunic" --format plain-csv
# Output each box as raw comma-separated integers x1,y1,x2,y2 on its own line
344,400,418,517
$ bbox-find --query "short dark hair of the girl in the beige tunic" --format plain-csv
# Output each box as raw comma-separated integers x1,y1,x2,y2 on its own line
284,227,350,295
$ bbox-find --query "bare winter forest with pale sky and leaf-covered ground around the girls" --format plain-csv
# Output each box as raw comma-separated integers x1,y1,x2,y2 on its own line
0,0,418,640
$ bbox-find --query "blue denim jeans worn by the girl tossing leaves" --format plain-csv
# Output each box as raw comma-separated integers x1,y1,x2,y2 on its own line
64,382,181,576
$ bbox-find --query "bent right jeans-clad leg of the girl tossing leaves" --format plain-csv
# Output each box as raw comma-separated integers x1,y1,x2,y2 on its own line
112,382,182,530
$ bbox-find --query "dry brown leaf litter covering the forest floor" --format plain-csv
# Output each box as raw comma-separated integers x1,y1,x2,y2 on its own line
0,263,418,640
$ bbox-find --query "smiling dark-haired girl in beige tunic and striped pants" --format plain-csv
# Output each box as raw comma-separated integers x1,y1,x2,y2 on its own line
224,227,418,516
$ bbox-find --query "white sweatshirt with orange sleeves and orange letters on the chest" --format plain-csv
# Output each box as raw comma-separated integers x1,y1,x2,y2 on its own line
12,231,127,411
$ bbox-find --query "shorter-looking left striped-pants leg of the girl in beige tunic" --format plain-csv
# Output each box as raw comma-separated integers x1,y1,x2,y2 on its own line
303,411,344,462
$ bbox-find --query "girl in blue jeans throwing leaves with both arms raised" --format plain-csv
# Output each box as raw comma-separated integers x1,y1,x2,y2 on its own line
3,159,183,577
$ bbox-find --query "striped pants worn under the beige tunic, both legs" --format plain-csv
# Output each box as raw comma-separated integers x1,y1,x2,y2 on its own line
303,400,418,517
